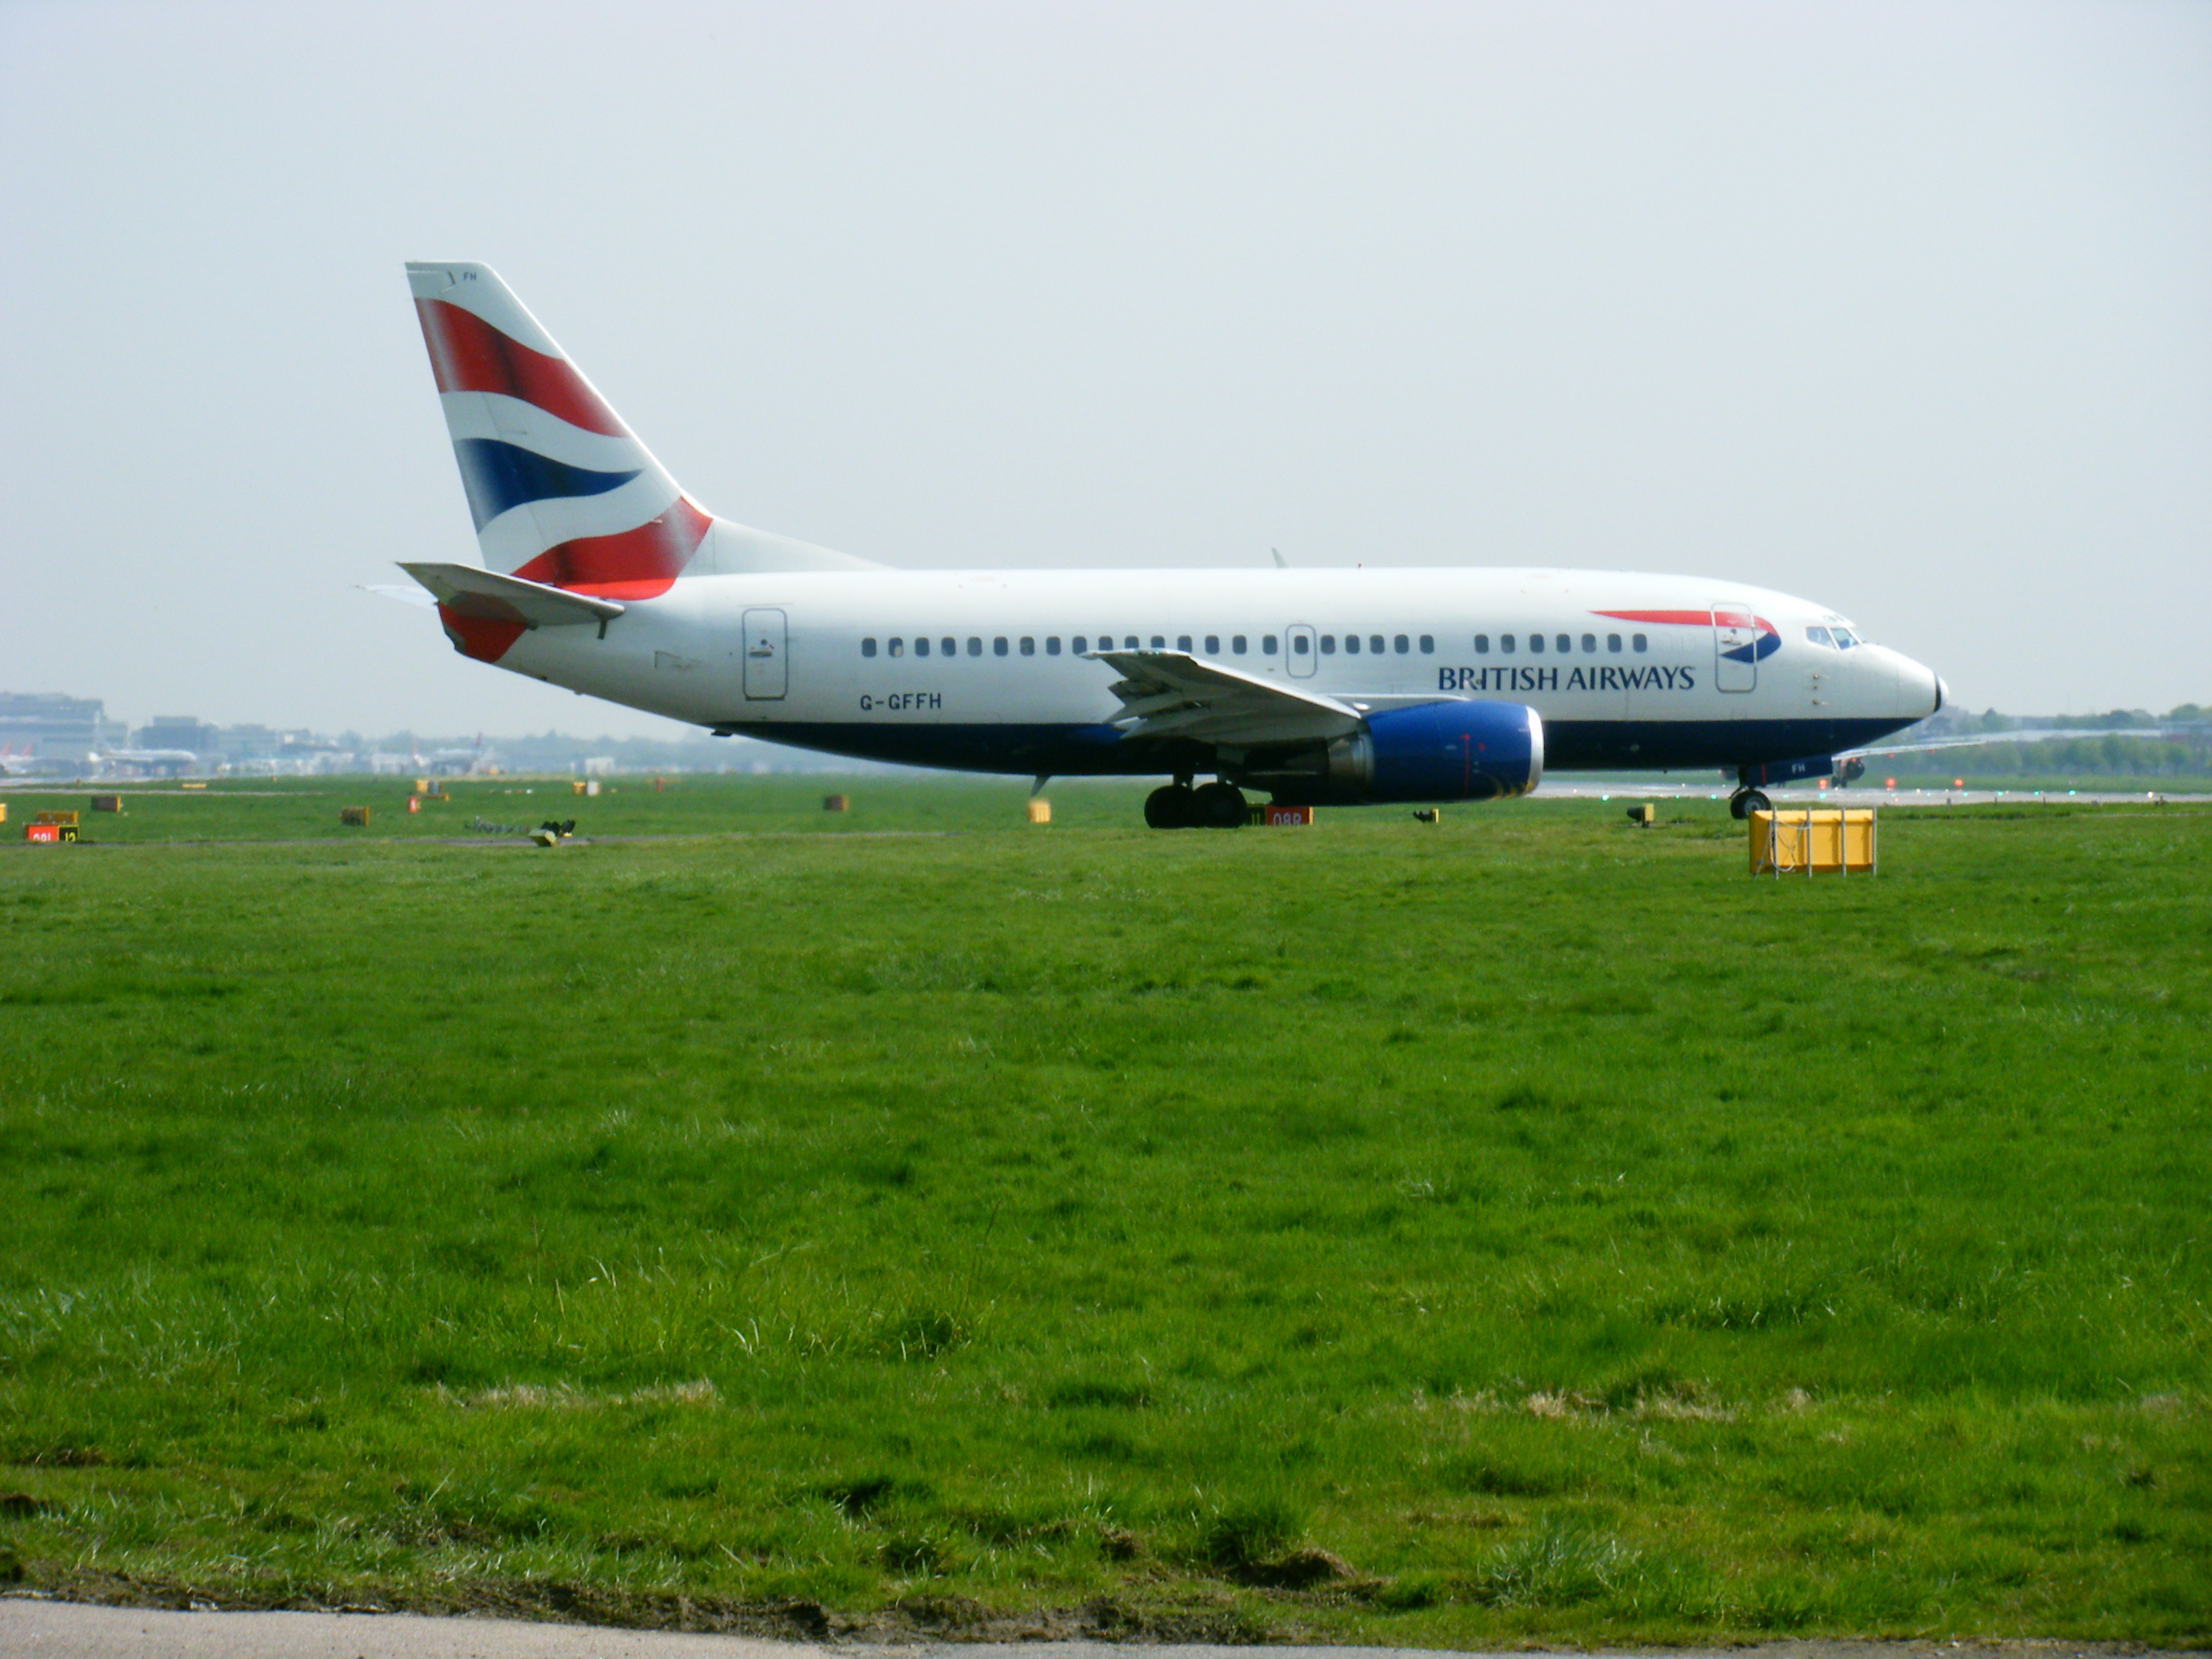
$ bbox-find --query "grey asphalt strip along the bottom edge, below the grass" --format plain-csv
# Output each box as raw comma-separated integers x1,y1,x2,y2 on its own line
0,1595,2212,1659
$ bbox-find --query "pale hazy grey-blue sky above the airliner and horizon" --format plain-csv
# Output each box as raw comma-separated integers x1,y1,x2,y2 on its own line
0,0,2212,735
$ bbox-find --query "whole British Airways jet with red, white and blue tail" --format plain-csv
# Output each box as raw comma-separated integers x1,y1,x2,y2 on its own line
401,263,1944,830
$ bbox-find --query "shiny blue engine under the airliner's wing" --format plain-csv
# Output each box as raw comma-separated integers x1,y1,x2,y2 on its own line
1239,701,1544,805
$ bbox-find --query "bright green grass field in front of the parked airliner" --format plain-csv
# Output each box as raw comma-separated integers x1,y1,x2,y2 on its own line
0,779,2212,1645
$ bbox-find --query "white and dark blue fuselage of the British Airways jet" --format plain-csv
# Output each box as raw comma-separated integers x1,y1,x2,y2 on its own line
471,569,1942,772
